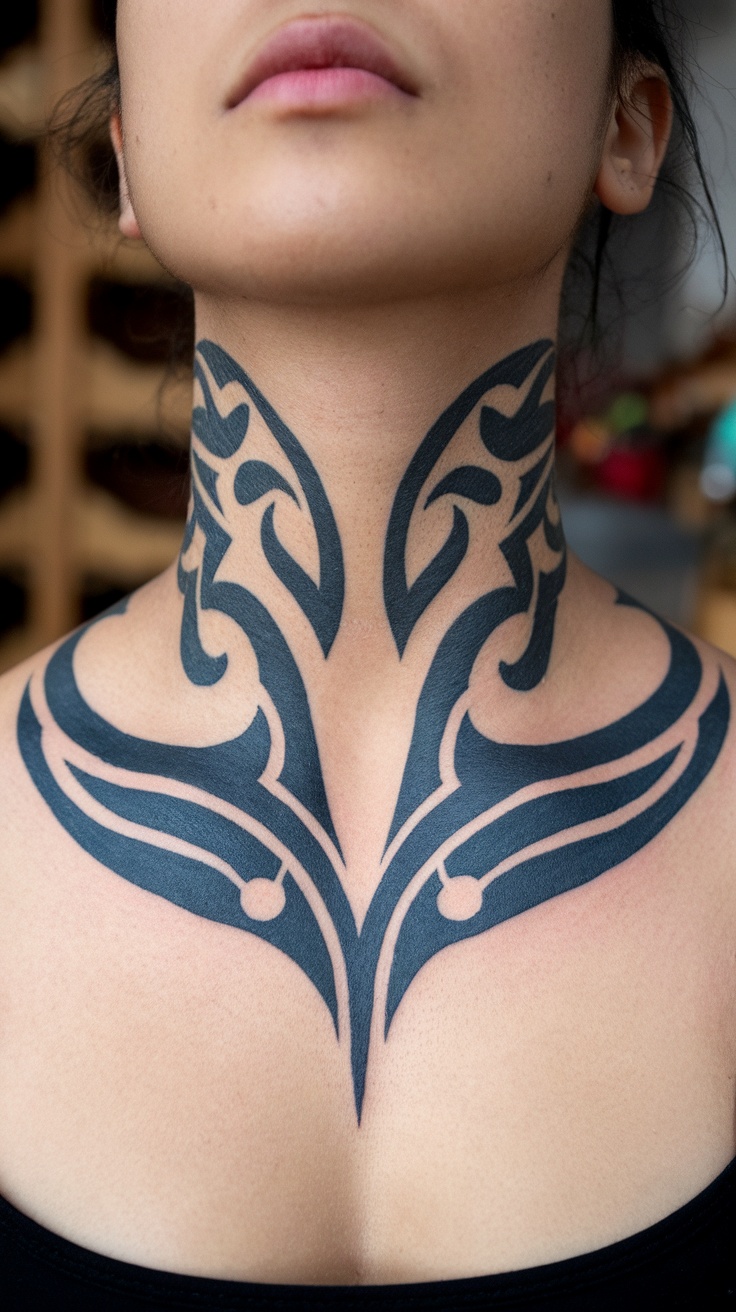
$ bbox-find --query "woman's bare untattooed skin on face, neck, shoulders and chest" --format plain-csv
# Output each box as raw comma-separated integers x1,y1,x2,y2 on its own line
0,0,736,1283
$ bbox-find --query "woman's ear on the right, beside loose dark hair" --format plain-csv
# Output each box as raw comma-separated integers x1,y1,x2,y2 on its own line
594,63,673,214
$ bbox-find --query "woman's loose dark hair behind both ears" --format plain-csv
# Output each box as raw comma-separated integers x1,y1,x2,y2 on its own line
50,0,728,369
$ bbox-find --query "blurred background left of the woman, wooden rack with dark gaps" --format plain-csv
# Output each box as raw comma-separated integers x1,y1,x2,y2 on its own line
0,0,190,669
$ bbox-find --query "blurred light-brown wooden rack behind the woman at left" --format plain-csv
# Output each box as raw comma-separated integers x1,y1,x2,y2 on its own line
0,0,190,669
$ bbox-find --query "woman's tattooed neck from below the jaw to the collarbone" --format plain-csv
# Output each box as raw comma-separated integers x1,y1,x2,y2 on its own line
178,289,565,881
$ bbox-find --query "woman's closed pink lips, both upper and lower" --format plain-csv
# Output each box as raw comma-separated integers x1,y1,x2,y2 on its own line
227,18,416,109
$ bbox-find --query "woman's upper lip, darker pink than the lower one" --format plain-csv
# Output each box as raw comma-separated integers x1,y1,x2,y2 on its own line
227,17,417,109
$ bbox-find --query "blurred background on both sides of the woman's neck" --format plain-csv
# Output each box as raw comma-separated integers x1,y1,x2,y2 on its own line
0,0,736,670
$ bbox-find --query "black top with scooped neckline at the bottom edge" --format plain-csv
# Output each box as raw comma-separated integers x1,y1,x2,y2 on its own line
0,1160,736,1312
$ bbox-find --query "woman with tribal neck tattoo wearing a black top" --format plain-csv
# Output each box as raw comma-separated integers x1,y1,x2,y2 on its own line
0,0,736,1308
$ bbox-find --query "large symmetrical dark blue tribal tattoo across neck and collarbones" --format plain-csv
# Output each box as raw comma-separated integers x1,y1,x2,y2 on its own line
18,341,729,1119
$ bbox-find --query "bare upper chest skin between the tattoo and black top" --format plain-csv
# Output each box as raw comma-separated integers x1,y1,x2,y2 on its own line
0,645,736,1282
